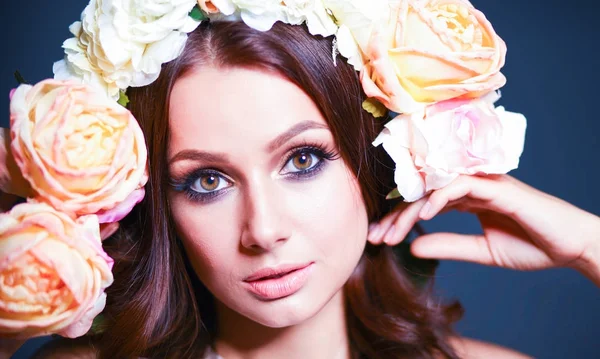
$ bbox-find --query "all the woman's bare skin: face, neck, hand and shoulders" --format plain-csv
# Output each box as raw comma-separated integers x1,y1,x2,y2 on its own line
5,68,600,359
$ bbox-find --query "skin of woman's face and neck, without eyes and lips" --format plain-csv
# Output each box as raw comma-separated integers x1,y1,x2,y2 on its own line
167,67,368,359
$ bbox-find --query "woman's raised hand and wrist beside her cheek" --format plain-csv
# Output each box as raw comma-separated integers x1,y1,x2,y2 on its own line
369,175,600,286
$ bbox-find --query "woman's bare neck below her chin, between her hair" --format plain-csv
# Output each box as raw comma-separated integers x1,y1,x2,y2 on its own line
215,291,351,359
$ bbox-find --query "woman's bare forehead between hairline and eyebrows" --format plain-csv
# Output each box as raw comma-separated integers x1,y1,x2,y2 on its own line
169,67,326,154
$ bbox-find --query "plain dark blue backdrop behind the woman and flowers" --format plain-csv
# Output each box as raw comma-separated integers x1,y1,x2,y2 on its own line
0,0,600,358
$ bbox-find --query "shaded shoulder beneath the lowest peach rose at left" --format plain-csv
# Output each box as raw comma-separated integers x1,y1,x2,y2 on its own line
32,337,98,359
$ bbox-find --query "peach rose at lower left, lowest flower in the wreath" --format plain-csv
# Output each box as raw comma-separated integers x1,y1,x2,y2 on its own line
0,202,113,338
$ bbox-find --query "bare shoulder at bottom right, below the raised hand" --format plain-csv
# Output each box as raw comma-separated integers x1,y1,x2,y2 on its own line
450,337,532,359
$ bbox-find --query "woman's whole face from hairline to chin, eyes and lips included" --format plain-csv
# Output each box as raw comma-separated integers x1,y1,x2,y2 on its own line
167,67,367,327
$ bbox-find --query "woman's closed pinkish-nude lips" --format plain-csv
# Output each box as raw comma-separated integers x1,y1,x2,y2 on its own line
244,262,313,300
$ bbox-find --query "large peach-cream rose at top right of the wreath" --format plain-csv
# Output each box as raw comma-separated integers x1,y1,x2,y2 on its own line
355,0,506,113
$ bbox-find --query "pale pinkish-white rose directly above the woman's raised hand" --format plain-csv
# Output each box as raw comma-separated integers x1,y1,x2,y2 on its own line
373,97,526,202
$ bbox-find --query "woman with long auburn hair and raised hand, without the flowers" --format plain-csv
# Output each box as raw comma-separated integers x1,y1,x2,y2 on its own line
1,0,600,358
